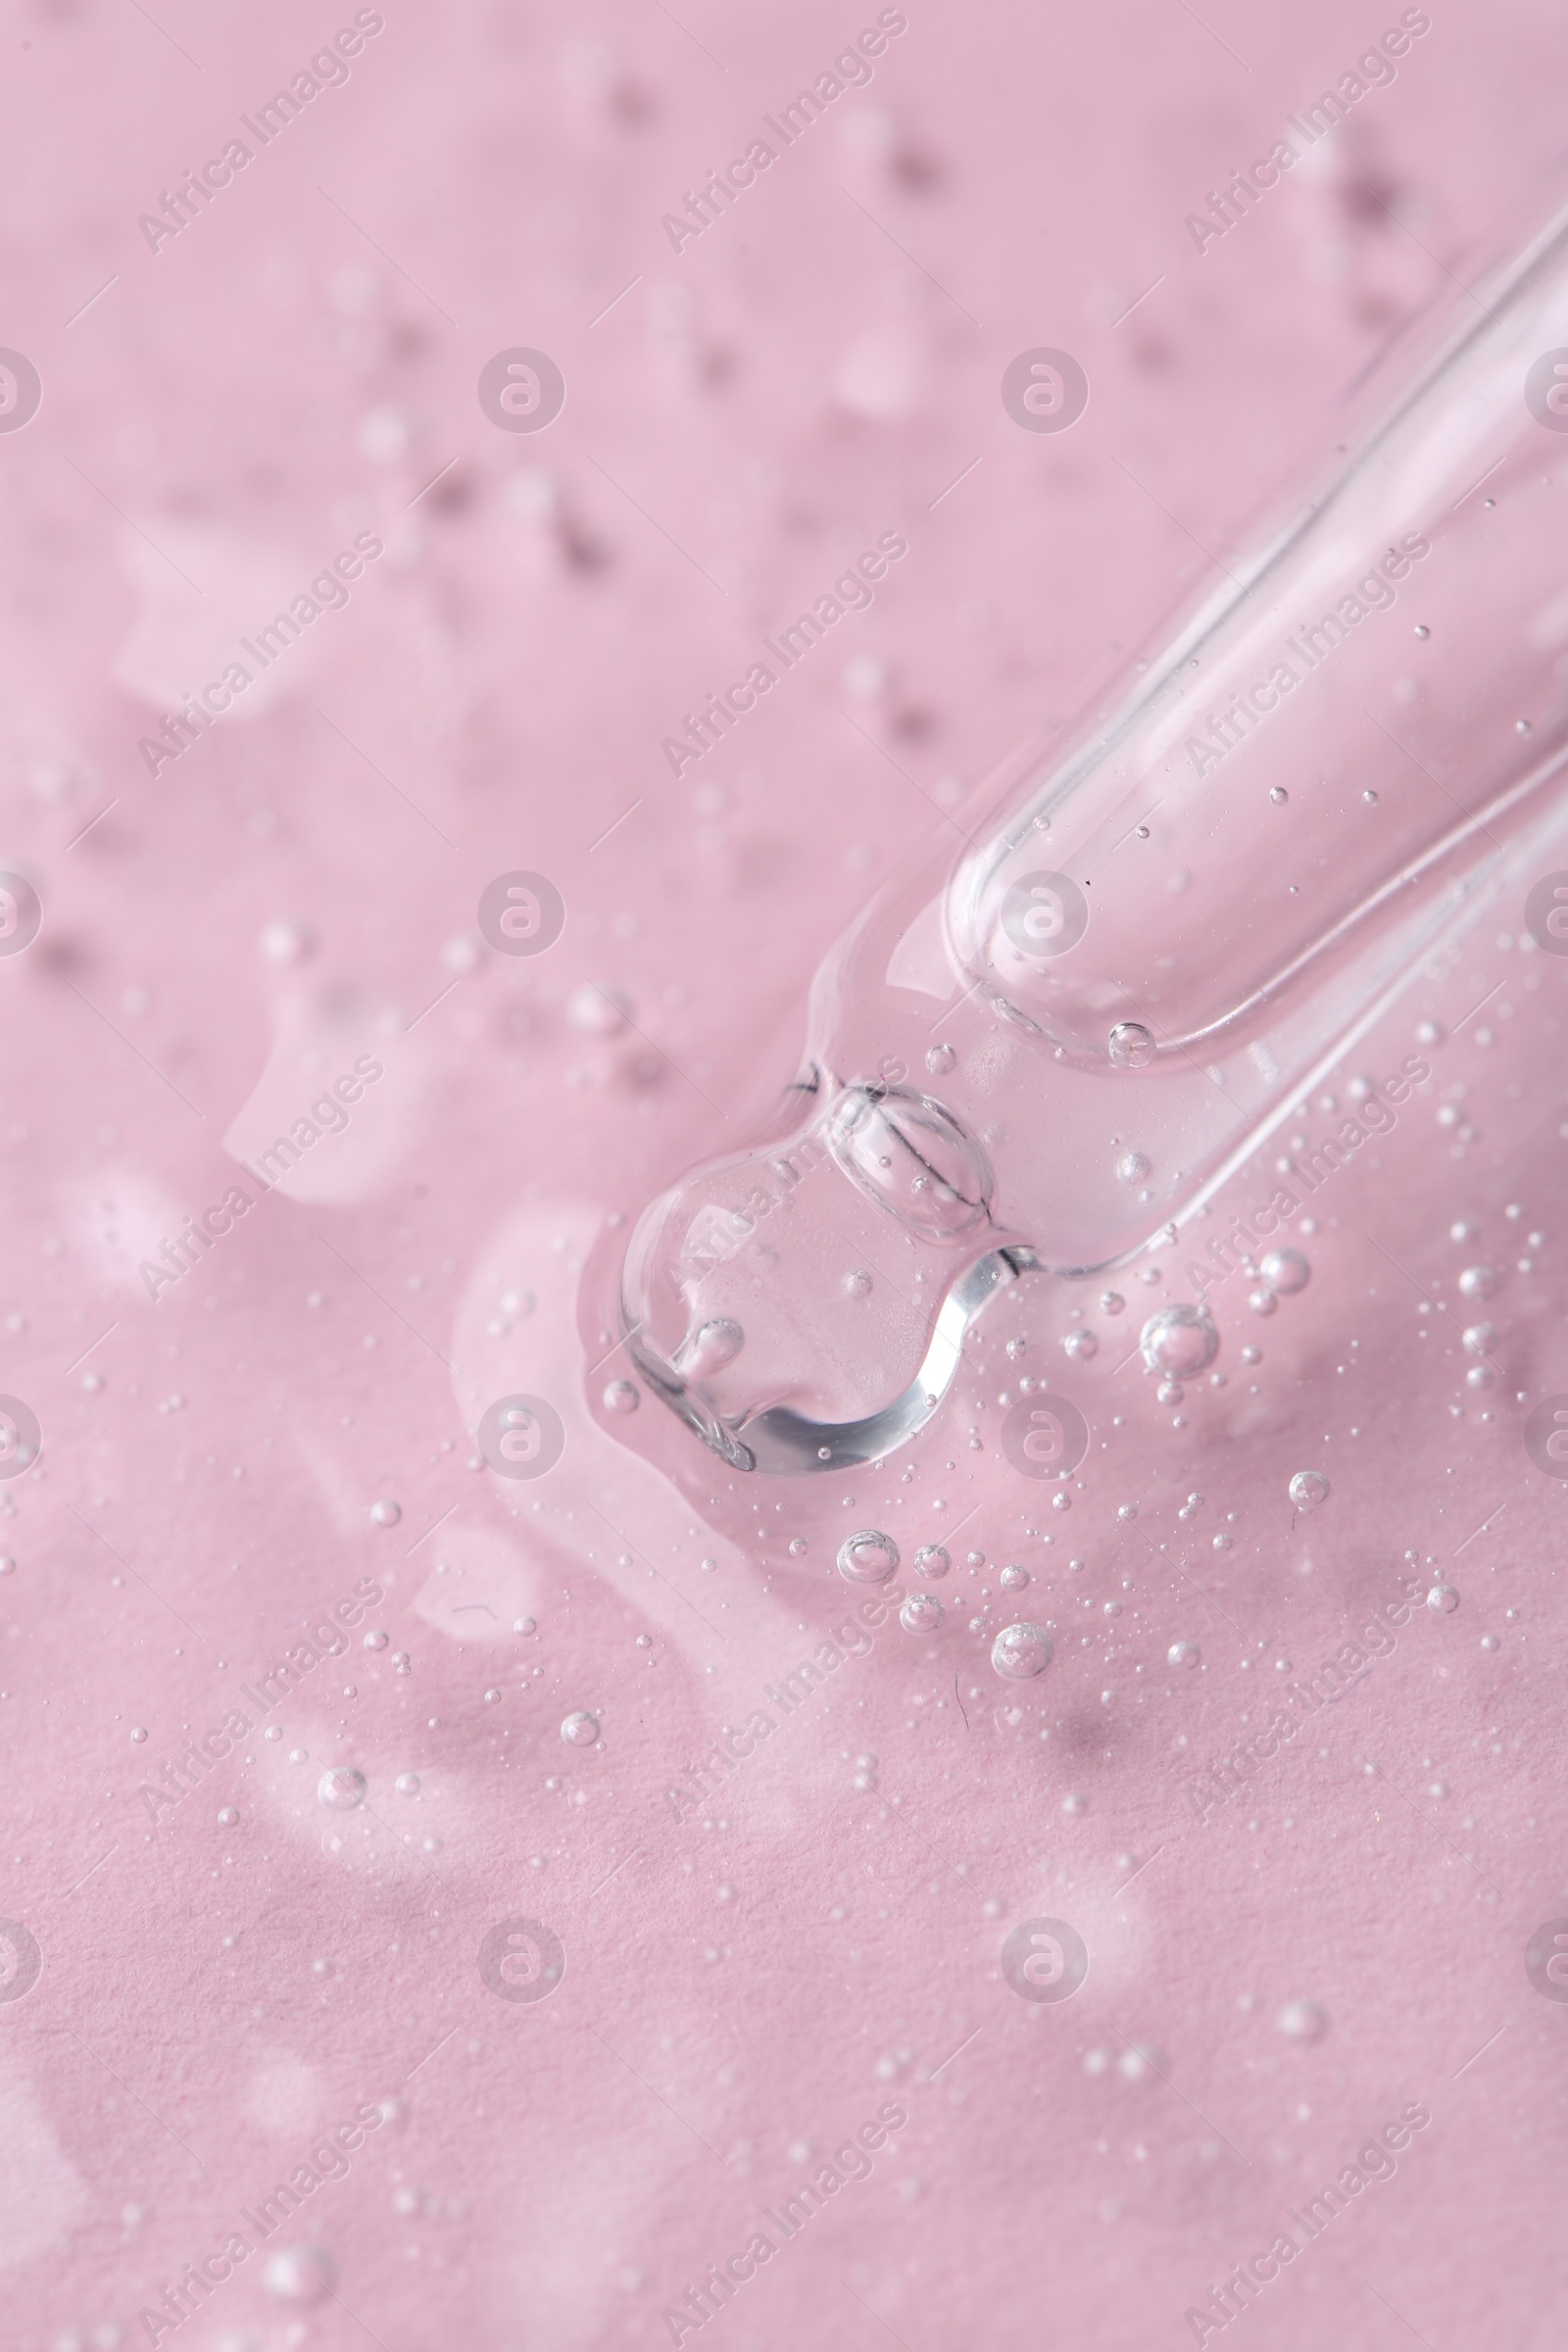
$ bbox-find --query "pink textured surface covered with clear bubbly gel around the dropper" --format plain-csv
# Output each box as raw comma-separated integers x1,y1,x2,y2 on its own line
0,0,1568,2352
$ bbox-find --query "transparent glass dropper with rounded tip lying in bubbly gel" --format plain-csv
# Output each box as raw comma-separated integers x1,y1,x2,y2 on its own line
613,183,1568,1475
